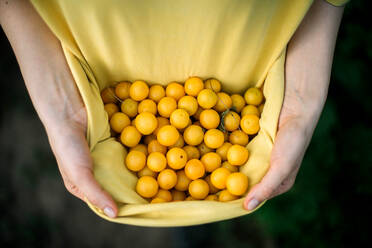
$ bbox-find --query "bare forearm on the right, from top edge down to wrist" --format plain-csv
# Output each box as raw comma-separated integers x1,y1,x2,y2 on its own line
285,0,343,126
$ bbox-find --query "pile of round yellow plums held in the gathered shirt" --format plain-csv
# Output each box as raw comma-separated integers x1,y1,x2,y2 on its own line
101,77,264,203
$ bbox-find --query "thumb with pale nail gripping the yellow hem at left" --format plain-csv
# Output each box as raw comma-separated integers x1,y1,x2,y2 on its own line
68,167,118,218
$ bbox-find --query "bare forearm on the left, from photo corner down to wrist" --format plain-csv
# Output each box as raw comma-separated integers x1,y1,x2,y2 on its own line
0,0,85,134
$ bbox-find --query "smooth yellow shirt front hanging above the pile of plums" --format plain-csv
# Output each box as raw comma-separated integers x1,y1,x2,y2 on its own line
33,0,345,92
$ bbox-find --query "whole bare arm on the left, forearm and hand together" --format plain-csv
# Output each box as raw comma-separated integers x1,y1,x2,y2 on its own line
0,0,117,217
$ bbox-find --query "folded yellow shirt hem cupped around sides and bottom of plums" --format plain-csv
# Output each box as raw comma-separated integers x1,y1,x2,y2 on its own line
61,46,285,226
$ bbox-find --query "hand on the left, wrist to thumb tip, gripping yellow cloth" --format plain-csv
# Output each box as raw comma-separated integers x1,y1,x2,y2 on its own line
45,107,117,218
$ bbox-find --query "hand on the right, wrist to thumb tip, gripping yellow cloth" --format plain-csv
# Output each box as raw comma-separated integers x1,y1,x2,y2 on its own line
244,84,322,210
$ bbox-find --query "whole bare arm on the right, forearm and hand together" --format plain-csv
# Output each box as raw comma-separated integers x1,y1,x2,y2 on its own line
243,0,343,210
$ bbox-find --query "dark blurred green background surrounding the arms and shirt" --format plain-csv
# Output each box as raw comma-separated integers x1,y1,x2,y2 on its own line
0,0,372,247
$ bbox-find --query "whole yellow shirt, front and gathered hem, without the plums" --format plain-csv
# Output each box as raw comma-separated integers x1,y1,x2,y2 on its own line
32,0,312,226
